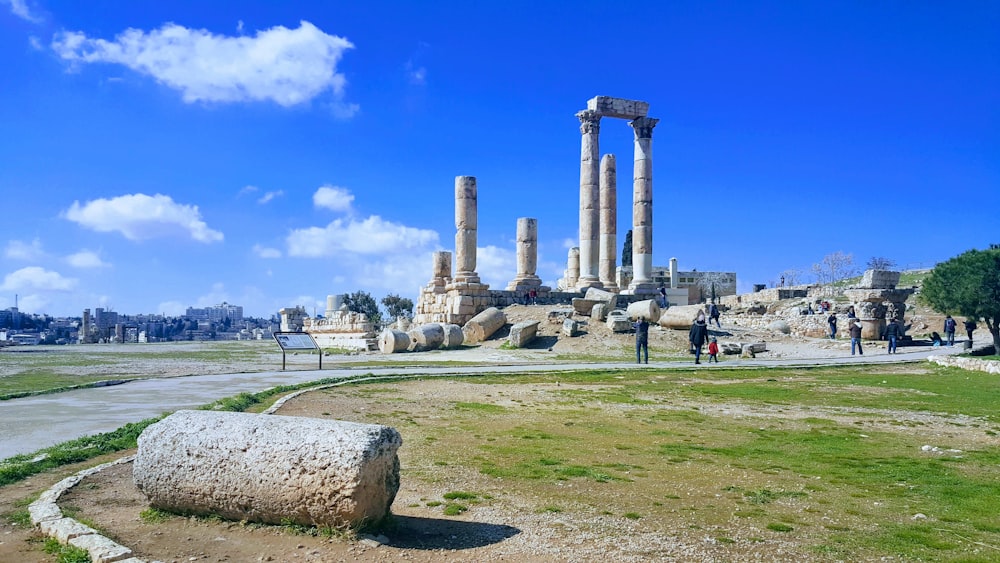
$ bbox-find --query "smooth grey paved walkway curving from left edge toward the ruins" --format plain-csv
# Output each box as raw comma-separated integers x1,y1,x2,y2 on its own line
0,346,963,460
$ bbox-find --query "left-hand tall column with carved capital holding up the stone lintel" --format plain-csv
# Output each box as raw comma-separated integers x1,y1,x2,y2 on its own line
576,110,601,289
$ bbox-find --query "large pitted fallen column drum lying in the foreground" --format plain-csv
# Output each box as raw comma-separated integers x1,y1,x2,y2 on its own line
132,411,402,526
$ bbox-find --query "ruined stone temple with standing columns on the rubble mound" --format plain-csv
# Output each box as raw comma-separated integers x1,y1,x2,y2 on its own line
414,96,736,324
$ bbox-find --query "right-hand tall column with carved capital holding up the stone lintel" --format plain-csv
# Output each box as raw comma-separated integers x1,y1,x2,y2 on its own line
629,117,660,294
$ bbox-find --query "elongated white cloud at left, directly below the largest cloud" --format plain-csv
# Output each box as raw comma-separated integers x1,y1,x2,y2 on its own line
65,194,223,243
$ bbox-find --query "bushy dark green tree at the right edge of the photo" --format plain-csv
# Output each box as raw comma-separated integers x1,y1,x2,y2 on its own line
920,246,1000,353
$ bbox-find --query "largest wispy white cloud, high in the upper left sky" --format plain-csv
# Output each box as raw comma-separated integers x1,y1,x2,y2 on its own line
52,21,354,107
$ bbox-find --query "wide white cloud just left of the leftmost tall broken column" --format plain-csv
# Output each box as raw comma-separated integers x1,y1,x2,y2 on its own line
286,215,438,258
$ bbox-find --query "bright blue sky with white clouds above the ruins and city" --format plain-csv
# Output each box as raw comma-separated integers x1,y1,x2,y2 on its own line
0,0,1000,316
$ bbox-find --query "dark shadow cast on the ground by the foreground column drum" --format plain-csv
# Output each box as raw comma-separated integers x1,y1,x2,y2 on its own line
382,515,521,550
